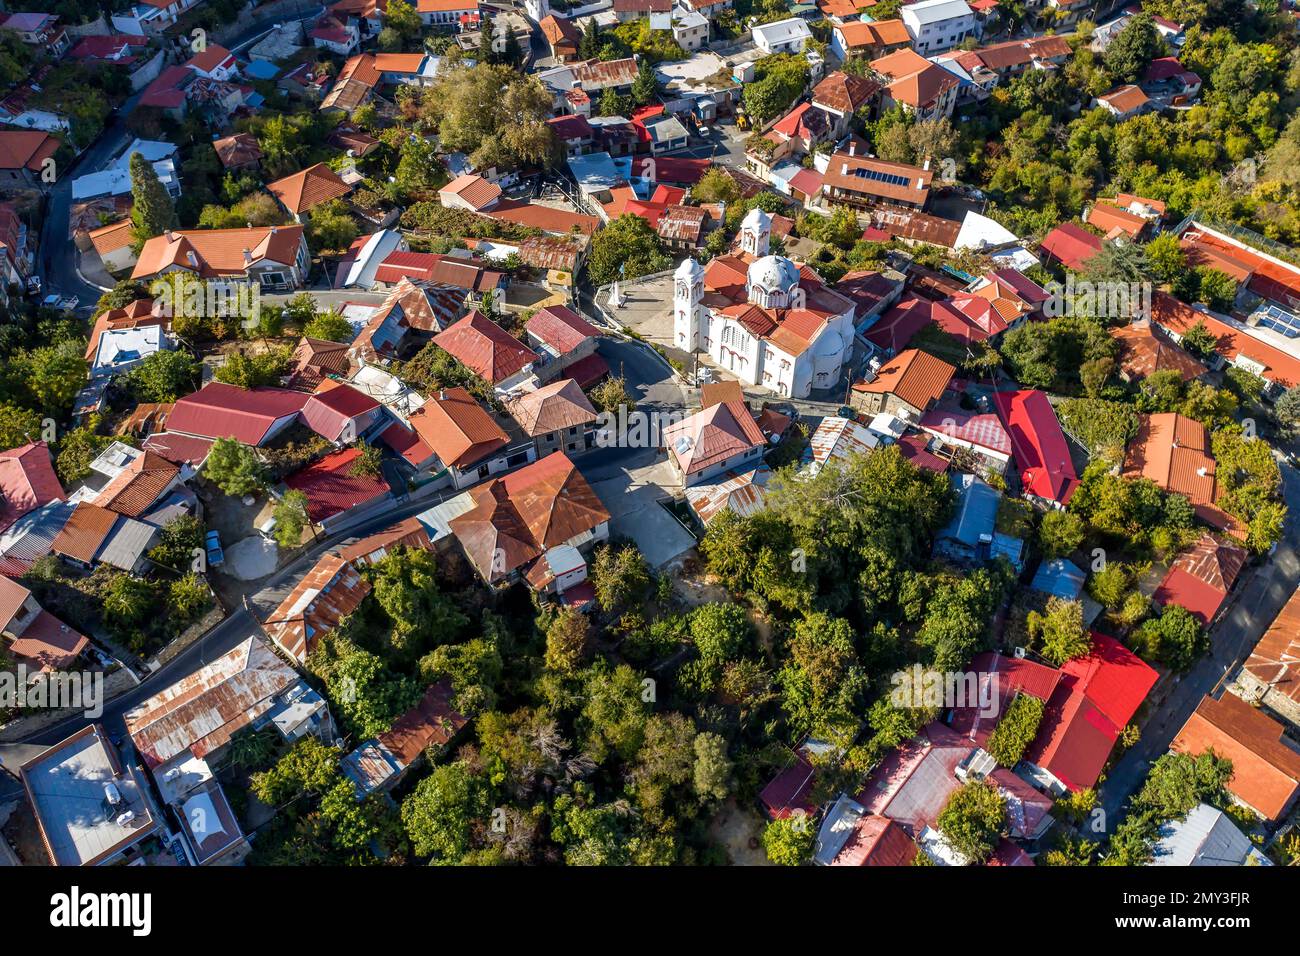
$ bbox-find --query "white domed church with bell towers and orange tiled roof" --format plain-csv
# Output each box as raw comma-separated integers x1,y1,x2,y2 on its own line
673,209,854,398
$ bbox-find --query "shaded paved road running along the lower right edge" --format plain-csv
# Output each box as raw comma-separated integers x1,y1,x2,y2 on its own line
1100,464,1300,831
